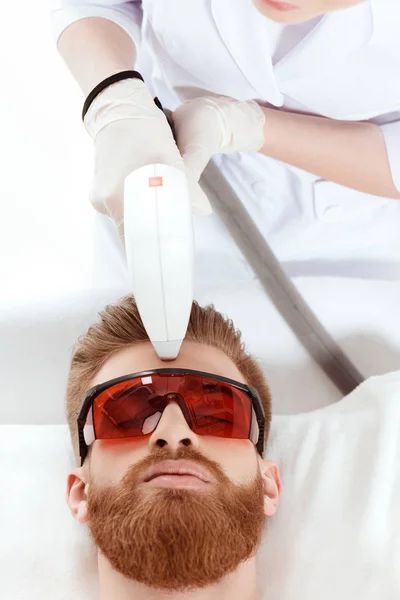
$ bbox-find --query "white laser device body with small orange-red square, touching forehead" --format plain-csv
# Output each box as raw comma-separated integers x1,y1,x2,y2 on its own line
124,164,194,360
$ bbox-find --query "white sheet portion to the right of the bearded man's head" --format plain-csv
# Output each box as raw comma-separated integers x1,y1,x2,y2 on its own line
259,371,400,600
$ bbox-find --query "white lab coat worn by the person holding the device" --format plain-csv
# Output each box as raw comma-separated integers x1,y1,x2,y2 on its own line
52,0,400,412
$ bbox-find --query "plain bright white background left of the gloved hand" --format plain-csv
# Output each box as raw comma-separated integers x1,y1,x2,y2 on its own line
0,0,92,303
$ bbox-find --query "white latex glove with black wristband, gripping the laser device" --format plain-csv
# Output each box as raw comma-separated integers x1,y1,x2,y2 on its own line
84,79,211,240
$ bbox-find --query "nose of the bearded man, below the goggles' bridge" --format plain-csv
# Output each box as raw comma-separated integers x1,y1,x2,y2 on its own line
149,402,199,451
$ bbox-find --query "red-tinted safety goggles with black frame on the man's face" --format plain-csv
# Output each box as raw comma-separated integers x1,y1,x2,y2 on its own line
78,369,265,464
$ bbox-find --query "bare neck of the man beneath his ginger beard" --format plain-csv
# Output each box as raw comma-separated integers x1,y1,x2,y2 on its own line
98,554,260,600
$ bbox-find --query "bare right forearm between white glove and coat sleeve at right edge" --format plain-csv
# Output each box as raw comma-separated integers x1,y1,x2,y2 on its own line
260,108,400,198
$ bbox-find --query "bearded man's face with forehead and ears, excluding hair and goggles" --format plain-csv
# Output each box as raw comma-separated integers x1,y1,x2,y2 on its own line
68,342,280,591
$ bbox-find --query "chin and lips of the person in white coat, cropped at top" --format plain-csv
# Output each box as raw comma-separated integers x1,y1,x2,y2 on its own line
253,0,365,24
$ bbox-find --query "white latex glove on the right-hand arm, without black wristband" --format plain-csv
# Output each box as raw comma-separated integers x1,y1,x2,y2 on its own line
173,96,265,181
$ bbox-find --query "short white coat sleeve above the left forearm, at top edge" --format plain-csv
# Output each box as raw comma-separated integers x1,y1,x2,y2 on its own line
49,0,143,48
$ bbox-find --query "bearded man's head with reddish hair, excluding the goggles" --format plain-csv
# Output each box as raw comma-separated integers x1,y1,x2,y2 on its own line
67,297,281,590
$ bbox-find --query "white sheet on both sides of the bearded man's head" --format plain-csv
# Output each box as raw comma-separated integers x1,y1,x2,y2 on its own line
0,371,400,600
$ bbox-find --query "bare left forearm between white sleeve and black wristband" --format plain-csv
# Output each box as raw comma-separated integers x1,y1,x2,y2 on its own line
58,17,136,96
